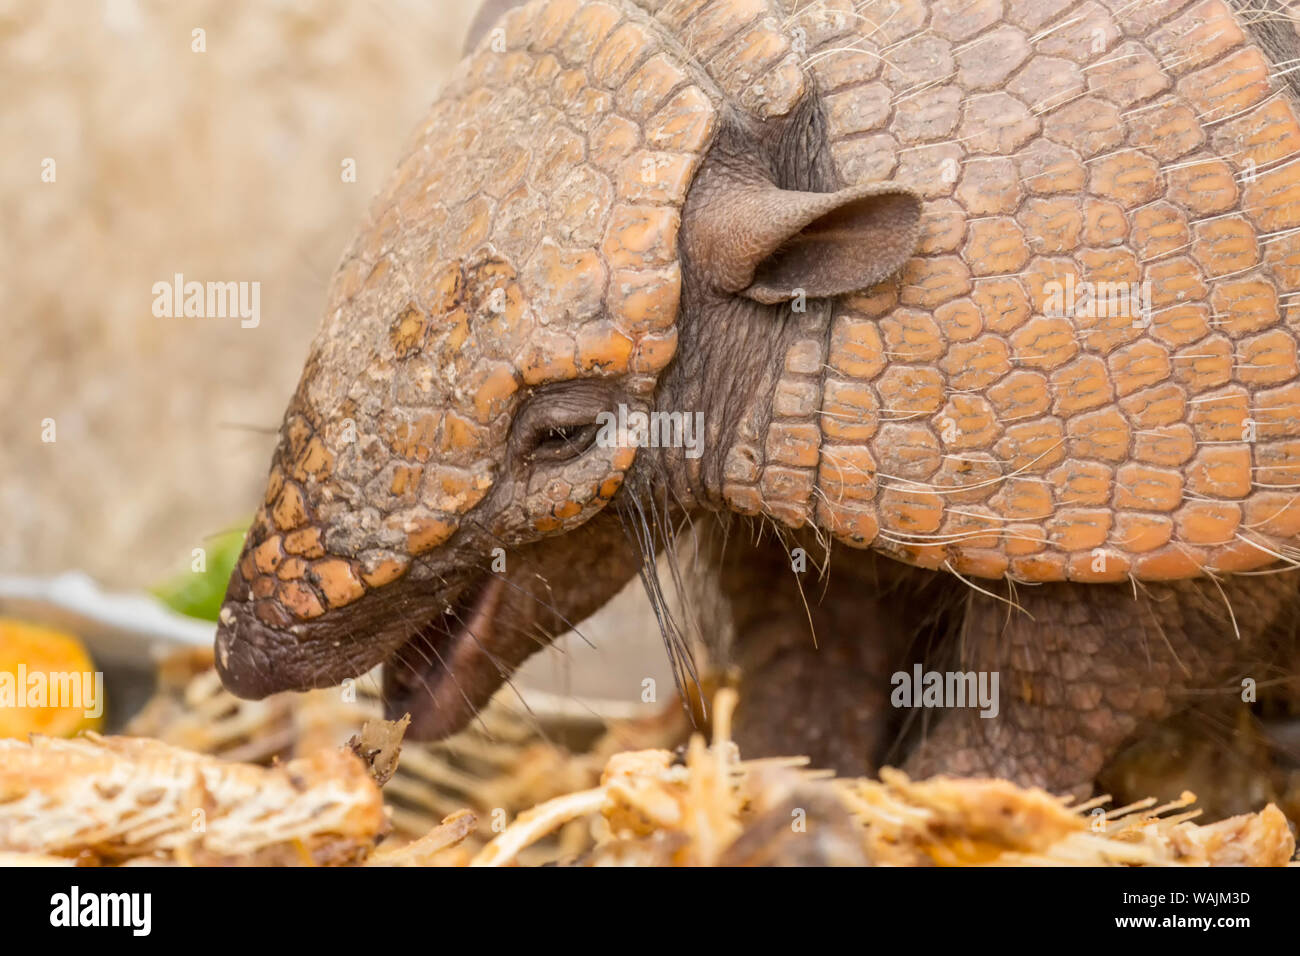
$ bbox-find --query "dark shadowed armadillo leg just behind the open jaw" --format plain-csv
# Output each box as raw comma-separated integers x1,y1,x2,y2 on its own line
722,545,946,775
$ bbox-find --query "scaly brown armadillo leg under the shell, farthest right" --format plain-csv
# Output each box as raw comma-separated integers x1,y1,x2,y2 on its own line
905,576,1296,792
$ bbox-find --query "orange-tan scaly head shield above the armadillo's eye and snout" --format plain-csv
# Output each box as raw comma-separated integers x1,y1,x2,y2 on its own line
231,0,728,628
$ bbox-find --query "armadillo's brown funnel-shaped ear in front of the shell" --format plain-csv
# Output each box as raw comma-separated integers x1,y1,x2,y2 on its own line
692,179,920,304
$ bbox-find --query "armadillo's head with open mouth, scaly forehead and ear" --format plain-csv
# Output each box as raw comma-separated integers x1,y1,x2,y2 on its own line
216,0,919,736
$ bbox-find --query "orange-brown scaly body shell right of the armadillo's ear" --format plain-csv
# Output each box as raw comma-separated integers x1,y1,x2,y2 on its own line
724,0,1300,581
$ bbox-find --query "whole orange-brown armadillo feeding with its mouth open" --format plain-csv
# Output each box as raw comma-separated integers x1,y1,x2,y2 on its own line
216,0,1300,790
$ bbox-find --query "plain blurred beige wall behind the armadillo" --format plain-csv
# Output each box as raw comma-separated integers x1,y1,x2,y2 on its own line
0,0,681,696
